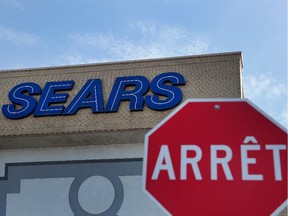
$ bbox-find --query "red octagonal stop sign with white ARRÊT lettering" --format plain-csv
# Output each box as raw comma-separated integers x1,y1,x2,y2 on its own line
143,99,287,216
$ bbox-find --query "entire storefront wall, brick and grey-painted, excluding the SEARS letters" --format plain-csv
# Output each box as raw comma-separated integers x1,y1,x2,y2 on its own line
0,52,243,216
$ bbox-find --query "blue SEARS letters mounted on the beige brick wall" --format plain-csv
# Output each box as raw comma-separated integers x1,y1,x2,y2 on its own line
2,72,185,119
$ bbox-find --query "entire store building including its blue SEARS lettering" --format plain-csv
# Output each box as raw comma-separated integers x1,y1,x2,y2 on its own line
0,52,243,216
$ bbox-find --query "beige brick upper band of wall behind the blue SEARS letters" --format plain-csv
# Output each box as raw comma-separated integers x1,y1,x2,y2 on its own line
0,52,243,138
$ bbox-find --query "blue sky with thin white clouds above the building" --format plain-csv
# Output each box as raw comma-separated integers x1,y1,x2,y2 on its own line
0,0,288,128
